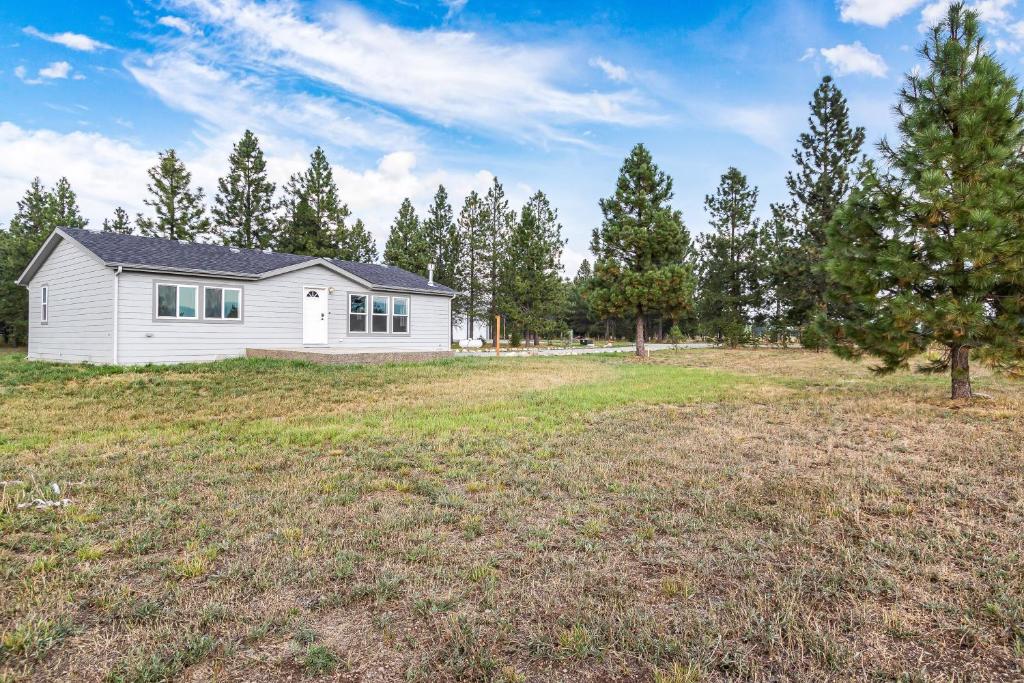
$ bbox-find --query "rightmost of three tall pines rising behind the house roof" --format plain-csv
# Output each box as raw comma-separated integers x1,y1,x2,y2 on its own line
275,147,354,260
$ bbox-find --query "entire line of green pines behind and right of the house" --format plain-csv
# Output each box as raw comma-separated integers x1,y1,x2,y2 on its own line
0,4,1024,397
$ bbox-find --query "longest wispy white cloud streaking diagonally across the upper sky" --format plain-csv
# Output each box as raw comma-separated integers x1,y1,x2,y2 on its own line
161,0,662,140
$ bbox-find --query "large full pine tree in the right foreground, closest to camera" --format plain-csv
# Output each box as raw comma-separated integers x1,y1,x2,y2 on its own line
825,3,1024,398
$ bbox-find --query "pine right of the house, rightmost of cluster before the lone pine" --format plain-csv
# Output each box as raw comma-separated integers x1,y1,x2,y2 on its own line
504,191,565,345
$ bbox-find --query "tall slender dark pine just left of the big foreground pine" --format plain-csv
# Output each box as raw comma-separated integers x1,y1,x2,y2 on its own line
785,76,864,326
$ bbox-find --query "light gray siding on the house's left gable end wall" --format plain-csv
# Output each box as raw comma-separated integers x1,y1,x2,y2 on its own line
29,240,114,362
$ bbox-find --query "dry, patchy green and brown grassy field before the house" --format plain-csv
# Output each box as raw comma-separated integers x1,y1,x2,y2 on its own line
0,350,1024,682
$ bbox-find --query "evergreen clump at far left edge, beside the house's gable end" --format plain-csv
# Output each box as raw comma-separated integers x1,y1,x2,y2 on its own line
0,178,89,343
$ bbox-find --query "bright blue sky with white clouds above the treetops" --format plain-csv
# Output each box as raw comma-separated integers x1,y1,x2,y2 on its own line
0,0,1024,274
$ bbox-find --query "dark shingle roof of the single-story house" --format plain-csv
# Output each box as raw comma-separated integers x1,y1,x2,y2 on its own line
60,227,455,294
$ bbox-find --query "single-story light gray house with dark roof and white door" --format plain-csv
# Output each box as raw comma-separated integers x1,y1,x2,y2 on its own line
17,228,455,365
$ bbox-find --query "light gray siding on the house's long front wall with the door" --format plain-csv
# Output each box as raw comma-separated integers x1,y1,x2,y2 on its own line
119,266,451,364
